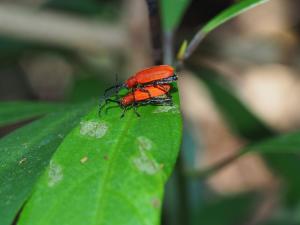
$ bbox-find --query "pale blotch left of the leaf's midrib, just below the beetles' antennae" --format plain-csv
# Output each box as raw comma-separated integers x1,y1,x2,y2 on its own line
80,121,108,138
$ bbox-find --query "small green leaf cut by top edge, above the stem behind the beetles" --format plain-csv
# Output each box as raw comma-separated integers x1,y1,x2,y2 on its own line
160,0,190,31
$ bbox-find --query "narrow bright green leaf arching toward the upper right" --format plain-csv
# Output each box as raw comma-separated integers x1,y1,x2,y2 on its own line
185,0,269,58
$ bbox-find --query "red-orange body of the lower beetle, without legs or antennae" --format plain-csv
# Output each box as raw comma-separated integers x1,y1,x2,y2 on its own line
121,84,171,106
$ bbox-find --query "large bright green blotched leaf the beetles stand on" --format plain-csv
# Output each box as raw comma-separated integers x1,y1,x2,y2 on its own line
18,94,182,225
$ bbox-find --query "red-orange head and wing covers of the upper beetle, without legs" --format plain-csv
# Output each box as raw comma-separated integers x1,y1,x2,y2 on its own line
126,65,174,88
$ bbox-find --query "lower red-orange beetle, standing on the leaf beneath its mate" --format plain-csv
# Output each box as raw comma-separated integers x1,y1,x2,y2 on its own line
99,84,173,118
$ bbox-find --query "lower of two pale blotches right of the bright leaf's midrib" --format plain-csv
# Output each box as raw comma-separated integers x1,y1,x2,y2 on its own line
133,152,161,175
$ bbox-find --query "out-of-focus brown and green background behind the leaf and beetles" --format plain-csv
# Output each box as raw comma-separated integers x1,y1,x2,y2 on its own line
0,0,300,225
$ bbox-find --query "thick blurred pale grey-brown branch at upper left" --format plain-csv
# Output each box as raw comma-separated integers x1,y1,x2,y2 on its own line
0,3,127,52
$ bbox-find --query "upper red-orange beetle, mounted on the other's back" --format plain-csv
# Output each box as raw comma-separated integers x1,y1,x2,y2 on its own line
104,65,178,96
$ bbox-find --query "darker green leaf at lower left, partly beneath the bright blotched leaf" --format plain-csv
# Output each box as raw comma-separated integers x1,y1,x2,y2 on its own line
0,105,89,225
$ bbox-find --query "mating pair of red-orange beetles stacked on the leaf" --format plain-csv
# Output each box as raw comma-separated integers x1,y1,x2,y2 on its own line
99,65,178,118
